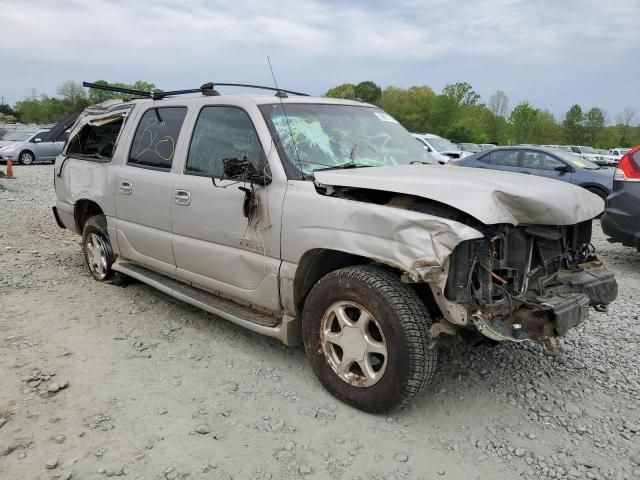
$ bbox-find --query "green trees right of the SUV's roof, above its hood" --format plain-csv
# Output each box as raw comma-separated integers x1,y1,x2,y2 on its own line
325,81,640,148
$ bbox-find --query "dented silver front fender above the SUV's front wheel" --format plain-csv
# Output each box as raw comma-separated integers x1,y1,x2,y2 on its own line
282,181,483,282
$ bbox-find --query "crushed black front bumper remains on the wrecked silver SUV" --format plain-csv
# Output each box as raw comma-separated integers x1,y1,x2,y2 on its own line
472,261,618,342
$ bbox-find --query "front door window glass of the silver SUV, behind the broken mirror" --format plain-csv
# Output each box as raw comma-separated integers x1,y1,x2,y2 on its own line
185,106,262,178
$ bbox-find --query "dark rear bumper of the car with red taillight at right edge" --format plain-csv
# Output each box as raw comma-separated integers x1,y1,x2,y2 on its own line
601,182,640,248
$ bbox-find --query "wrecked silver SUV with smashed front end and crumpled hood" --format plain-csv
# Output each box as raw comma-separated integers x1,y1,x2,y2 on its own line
54,84,617,412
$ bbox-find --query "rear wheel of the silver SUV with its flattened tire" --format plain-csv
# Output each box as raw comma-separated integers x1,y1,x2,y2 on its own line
82,215,127,285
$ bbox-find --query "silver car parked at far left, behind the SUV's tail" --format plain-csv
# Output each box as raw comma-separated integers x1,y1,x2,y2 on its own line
0,130,65,165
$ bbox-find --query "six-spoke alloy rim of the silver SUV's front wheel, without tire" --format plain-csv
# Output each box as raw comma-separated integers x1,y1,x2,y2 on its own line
320,301,389,387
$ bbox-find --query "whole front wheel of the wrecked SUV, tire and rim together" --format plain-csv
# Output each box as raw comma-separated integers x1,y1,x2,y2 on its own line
302,265,437,413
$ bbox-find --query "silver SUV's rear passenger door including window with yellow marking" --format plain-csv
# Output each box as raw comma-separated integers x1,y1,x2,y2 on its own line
114,107,187,277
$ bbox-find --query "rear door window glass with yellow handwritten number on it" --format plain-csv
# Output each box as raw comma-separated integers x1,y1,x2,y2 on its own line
127,107,187,170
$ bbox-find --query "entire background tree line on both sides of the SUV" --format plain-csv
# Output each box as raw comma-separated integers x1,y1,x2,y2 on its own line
0,80,640,148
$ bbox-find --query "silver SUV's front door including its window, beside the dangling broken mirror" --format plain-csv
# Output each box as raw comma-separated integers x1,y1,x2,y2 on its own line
171,106,284,313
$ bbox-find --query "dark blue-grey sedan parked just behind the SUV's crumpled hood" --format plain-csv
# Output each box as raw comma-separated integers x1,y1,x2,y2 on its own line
452,146,613,199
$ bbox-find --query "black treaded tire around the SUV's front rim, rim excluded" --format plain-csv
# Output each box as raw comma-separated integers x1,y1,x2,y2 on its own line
302,265,437,413
